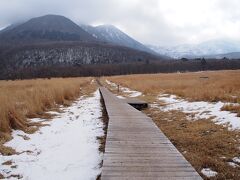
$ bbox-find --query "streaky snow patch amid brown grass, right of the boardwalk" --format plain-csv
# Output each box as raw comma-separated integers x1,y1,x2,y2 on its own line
158,94,240,129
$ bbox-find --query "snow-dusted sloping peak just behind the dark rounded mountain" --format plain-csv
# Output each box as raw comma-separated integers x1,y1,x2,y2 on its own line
80,25,156,54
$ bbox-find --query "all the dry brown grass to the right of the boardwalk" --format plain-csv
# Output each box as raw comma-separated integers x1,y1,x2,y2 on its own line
101,70,240,180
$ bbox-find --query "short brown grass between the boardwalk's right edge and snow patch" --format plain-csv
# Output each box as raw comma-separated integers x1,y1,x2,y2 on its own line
145,108,240,180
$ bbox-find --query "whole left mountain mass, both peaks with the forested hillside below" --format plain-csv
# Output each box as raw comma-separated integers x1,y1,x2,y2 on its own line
0,15,169,79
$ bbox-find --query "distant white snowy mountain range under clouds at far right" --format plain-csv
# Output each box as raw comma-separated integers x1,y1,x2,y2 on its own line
148,40,240,58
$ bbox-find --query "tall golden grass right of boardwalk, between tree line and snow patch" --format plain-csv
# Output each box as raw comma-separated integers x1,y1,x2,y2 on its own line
105,70,240,103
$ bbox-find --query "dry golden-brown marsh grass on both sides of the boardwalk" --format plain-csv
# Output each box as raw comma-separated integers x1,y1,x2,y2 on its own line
0,70,240,179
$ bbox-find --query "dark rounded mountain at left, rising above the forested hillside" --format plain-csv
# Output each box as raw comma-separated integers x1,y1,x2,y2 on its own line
0,15,97,44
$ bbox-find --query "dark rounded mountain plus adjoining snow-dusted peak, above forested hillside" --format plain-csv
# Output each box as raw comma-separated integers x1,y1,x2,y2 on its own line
0,14,165,56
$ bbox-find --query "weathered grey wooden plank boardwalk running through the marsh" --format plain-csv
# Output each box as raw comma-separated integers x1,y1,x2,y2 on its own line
100,87,202,180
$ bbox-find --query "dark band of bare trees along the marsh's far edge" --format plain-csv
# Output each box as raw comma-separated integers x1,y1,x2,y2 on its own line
0,59,240,80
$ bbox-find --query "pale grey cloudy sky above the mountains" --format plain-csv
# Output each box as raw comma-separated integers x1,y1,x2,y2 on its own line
0,0,240,45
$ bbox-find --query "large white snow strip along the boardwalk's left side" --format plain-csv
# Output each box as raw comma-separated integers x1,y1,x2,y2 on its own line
0,91,104,180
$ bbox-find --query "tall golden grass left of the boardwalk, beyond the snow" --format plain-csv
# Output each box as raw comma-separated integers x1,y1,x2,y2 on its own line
0,78,95,154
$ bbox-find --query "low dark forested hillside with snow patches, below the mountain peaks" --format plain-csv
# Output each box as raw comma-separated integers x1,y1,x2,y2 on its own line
0,42,159,71
